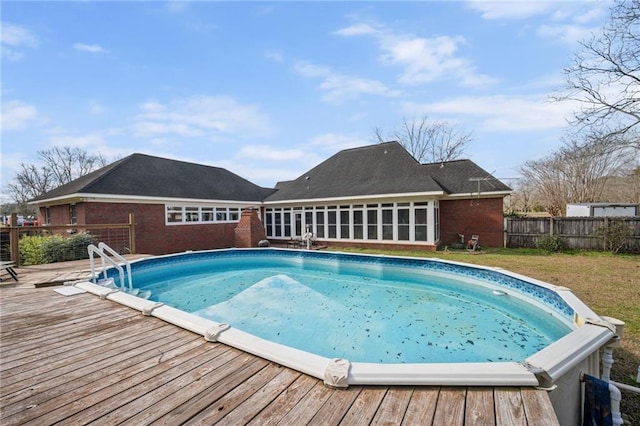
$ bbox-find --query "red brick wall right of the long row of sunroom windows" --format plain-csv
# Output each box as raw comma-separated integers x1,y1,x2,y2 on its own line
440,198,504,247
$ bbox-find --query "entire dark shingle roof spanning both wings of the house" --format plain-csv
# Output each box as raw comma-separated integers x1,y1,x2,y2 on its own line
31,142,511,206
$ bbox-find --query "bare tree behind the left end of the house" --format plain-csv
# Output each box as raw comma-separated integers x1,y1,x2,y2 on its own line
7,147,107,213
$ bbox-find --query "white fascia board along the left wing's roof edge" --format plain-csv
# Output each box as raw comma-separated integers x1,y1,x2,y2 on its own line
29,193,262,206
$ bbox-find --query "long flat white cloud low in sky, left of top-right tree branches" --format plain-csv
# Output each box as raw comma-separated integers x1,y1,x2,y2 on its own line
404,95,575,133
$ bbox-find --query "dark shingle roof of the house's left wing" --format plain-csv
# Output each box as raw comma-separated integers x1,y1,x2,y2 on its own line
31,154,275,202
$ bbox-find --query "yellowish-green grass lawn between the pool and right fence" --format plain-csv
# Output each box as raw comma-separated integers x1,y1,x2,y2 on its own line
329,248,640,424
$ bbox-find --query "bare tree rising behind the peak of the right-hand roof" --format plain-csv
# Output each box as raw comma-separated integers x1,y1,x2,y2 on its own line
373,115,472,163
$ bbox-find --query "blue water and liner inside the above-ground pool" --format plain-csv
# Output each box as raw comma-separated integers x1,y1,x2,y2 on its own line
124,249,572,363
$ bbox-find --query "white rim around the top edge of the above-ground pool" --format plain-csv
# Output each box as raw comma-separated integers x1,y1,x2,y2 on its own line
73,249,615,387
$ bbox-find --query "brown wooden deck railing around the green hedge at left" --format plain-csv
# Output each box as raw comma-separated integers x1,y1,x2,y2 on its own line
0,214,136,266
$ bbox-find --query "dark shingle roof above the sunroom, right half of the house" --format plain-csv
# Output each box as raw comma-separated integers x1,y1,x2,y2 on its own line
265,142,511,202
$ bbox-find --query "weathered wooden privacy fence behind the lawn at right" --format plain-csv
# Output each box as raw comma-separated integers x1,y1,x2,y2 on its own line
505,217,640,252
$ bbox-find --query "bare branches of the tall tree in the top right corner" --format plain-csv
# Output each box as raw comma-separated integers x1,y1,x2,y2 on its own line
555,0,640,149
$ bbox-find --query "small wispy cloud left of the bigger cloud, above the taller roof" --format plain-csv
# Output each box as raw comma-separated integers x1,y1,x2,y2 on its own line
294,61,401,102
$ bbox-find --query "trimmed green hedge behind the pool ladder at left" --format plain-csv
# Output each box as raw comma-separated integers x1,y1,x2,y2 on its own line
18,232,95,265
